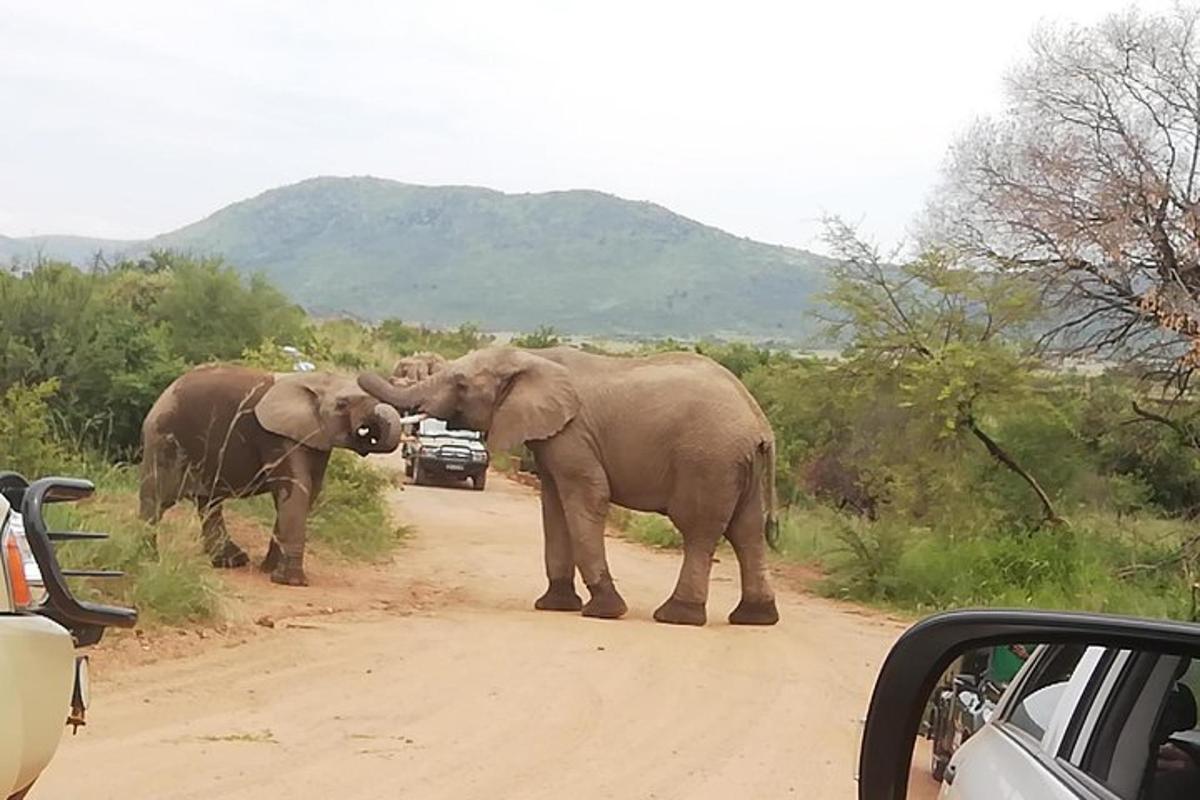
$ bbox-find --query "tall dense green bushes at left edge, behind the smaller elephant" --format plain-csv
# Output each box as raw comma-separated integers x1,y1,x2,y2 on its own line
0,253,305,457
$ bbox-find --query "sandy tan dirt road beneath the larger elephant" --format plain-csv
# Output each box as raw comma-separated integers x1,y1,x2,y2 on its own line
30,455,916,800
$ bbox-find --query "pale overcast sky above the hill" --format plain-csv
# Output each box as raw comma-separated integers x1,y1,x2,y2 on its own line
0,0,1169,249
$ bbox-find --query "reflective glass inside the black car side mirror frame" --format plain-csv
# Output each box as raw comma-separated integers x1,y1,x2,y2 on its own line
907,642,1200,800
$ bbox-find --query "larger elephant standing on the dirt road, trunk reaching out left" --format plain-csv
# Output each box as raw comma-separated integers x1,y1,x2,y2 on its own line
359,347,779,625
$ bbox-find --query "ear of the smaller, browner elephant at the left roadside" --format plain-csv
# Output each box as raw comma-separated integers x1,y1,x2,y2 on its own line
254,372,346,450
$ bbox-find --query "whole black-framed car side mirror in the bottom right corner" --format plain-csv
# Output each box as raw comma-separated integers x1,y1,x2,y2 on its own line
858,609,1200,800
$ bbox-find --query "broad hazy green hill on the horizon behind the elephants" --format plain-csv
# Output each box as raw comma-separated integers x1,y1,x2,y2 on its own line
0,178,826,338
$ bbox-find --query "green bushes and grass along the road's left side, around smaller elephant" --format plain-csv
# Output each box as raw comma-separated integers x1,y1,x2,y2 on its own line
0,252,448,624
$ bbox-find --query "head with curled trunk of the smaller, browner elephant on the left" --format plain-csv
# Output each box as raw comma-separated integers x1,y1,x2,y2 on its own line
254,372,402,456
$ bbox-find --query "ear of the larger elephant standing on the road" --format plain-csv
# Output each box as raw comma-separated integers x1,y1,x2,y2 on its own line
487,350,580,451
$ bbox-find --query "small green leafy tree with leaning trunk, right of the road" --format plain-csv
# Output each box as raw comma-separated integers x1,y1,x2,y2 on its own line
827,219,1061,522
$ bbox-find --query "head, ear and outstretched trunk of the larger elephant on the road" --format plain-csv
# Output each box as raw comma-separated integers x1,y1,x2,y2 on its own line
359,347,580,451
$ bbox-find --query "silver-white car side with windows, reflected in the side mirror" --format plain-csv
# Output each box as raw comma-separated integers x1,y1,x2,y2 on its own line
942,648,1200,800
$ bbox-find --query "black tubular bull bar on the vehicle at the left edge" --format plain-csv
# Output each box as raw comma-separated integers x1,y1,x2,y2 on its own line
0,473,138,646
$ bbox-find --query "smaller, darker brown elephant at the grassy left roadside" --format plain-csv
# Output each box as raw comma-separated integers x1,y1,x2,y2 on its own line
139,365,401,585
